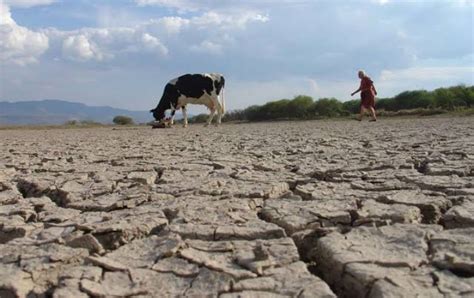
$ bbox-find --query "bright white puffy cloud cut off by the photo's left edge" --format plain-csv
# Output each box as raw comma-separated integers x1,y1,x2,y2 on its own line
0,3,49,65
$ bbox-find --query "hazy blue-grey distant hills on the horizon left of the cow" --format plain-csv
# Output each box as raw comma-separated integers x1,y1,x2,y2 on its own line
0,100,153,125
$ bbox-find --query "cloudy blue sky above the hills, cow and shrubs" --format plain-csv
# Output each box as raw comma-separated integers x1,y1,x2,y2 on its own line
0,0,474,112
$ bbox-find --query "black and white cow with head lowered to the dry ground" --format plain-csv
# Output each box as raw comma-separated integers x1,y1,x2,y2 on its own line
150,73,225,127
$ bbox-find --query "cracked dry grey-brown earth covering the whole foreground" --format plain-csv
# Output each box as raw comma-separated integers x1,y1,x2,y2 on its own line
0,118,474,297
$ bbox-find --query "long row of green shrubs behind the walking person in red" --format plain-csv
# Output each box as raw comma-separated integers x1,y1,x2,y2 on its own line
217,85,474,121
